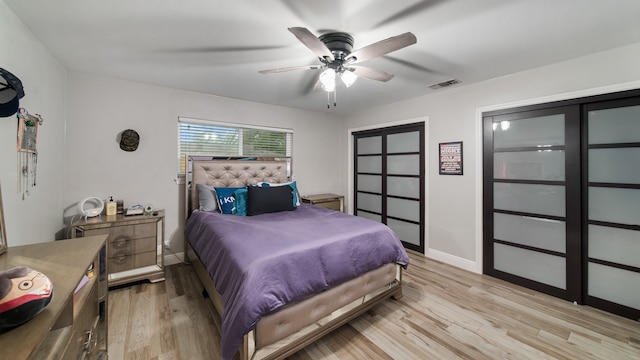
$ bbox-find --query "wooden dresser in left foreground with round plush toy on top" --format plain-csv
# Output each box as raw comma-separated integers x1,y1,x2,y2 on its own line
0,235,108,360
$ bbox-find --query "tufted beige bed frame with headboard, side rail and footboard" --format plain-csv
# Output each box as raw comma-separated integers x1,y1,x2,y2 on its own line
185,156,402,360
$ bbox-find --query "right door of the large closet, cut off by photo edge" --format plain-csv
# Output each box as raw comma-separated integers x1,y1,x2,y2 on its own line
583,97,640,319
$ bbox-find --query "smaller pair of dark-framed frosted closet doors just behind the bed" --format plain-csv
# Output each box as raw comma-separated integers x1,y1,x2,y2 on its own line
353,124,425,252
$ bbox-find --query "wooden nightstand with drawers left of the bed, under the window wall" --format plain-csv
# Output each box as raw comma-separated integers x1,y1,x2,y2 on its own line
71,211,164,286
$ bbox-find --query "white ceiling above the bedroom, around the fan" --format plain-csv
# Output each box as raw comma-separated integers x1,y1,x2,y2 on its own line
4,0,640,114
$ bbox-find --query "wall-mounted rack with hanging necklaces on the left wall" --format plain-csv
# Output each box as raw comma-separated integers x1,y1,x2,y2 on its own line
17,108,43,200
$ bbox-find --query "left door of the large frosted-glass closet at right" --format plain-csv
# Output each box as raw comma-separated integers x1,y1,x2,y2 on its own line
483,106,581,301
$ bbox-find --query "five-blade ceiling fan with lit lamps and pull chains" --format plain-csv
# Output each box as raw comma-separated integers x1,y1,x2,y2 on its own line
259,27,417,107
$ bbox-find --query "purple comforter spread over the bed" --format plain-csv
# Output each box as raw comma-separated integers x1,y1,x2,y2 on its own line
185,204,409,360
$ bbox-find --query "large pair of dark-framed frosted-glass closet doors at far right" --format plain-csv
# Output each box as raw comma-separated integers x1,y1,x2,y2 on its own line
483,89,640,320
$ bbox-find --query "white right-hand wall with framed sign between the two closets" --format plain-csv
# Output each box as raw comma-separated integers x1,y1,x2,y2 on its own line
342,43,640,272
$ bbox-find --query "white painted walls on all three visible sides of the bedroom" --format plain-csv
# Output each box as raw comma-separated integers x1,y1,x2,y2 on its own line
5,1,640,271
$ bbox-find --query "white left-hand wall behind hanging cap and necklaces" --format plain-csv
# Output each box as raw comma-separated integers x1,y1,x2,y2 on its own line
0,1,66,246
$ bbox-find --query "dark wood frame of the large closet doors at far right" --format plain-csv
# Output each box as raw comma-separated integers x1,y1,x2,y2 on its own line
482,89,640,320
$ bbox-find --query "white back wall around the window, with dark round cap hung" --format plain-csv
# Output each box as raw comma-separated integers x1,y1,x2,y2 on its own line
64,73,344,253
